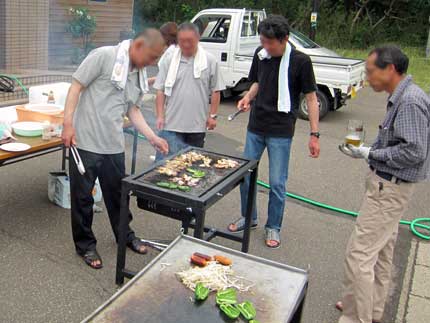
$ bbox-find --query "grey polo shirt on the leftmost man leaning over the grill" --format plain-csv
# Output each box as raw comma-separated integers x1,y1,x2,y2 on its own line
73,46,143,154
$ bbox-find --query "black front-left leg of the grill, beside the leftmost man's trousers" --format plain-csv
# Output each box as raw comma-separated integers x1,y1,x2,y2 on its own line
116,183,129,285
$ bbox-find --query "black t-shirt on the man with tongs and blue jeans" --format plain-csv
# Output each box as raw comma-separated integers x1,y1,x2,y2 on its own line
248,47,317,138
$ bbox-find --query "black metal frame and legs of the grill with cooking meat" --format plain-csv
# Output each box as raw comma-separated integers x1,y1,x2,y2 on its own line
116,147,258,285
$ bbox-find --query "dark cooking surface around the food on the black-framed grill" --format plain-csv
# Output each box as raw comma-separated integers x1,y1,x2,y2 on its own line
137,148,248,196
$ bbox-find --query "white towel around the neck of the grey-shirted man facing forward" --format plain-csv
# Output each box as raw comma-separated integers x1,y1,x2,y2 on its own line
164,46,208,96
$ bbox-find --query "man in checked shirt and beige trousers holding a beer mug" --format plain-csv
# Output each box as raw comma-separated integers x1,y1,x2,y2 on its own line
336,46,430,323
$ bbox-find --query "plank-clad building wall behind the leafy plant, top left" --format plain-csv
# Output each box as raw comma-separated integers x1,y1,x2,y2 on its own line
49,0,133,65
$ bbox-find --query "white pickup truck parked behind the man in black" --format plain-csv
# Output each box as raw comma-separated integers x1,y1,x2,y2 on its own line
191,9,365,119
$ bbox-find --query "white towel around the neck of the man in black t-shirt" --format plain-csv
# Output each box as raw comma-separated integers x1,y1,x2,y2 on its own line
257,43,291,113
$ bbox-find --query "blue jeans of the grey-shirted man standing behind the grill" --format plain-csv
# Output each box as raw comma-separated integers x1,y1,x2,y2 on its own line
155,130,206,162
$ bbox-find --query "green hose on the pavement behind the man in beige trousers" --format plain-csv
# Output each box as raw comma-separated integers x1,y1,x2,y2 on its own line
257,180,430,240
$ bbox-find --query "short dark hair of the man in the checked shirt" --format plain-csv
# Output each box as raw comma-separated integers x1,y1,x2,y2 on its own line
369,46,409,75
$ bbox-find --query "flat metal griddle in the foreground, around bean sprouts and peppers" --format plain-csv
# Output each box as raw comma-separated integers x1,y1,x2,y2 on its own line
84,235,308,323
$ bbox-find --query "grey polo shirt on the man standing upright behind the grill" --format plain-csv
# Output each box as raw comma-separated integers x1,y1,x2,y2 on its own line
154,51,225,133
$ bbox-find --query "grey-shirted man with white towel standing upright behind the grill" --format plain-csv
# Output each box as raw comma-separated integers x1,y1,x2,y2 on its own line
154,23,225,160
